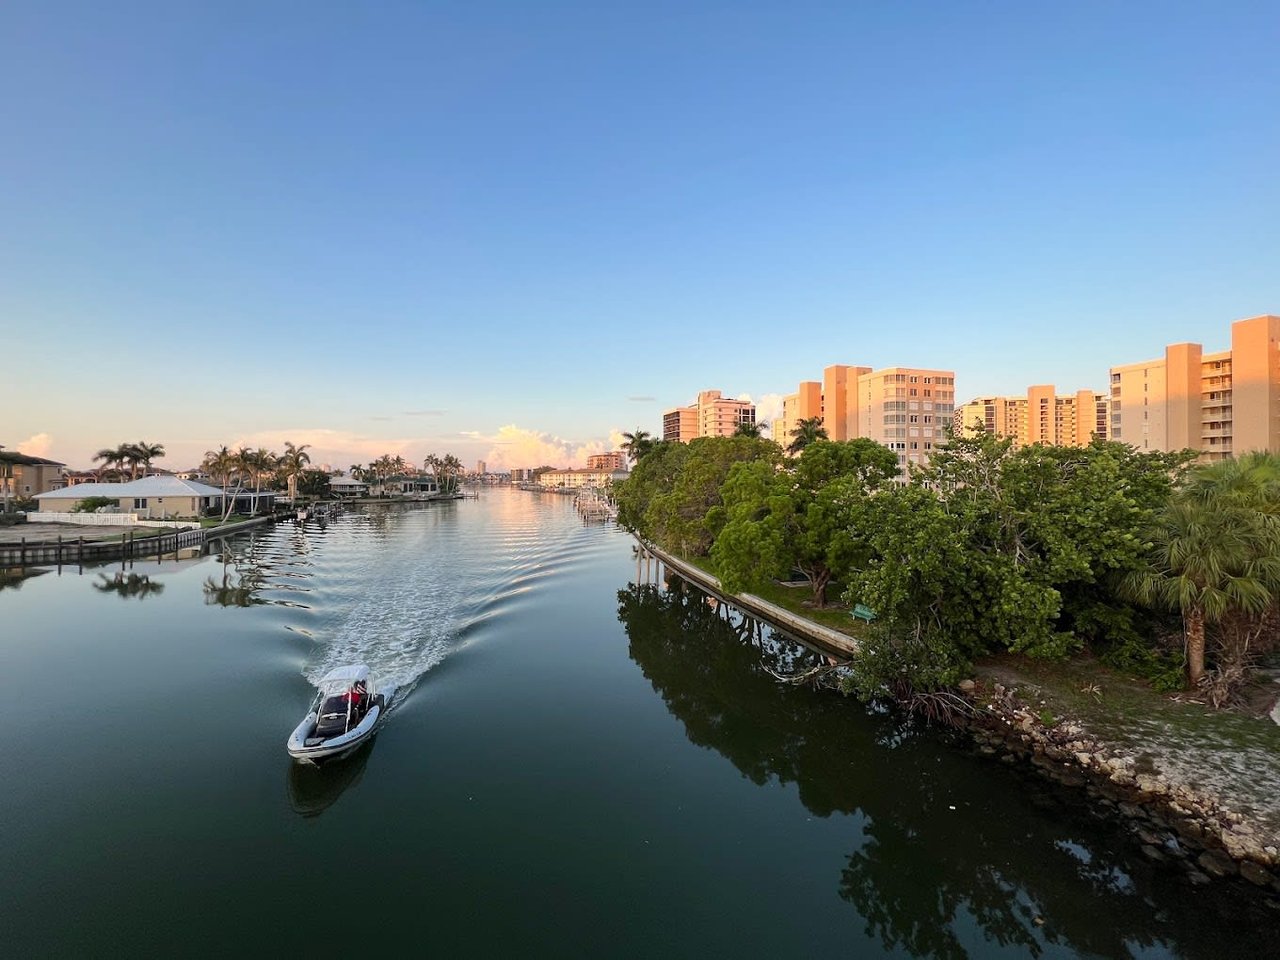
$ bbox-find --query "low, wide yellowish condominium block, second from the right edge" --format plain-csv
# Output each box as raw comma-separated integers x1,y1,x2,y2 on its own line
954,384,1111,447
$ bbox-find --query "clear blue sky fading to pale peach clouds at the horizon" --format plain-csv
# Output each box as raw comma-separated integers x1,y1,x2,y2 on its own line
0,0,1280,468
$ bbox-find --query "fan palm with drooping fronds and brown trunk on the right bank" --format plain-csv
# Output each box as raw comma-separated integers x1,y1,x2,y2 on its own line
1123,488,1280,686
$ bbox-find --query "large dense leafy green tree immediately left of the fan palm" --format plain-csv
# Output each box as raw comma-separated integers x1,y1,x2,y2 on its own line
841,433,1185,701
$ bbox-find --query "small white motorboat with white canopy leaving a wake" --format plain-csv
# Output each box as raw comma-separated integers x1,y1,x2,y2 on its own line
288,663,394,763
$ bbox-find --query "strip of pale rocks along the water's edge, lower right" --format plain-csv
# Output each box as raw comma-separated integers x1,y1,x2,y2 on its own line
959,681,1280,908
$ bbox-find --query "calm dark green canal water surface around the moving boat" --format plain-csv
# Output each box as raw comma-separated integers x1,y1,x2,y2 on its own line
0,490,1277,959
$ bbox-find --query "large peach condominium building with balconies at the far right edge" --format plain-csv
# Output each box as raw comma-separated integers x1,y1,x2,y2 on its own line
1111,314,1280,461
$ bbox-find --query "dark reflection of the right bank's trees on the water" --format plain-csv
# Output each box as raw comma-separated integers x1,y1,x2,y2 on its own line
618,585,1276,960
